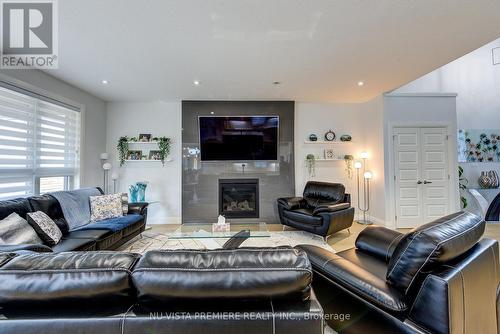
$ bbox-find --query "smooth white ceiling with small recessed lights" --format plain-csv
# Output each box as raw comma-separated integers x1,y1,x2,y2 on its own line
47,0,500,102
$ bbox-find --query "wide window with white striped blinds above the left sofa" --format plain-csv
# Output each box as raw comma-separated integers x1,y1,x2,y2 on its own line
0,83,80,200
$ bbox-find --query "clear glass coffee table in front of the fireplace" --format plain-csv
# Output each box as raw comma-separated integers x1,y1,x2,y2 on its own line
169,223,271,239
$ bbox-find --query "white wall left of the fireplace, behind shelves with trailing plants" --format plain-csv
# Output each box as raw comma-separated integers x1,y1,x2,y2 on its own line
106,102,182,224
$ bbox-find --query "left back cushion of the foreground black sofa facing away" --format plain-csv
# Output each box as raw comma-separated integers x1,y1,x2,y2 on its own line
0,252,138,307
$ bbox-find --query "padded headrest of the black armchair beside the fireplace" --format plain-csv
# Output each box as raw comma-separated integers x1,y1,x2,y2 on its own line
303,181,345,208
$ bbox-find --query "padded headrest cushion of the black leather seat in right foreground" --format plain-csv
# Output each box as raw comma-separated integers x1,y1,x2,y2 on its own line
387,212,485,293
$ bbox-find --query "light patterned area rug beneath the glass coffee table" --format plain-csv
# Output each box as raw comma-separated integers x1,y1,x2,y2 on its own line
118,231,334,254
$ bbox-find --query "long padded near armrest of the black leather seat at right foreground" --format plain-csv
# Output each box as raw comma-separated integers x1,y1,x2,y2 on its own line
297,245,408,313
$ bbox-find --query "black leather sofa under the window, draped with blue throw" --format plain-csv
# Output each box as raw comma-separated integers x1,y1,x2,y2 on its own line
0,188,148,252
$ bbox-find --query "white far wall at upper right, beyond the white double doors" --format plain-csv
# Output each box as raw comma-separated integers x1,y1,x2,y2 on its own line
394,39,500,187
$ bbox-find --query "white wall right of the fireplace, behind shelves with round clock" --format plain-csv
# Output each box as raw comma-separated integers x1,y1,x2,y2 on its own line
295,97,385,224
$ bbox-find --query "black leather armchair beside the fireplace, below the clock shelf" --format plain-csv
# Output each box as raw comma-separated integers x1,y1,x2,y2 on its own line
278,182,354,239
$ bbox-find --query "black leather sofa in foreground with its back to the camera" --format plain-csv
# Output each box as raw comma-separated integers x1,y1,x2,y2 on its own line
0,247,323,334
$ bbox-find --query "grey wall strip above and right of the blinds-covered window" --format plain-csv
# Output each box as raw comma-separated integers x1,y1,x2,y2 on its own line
0,70,106,187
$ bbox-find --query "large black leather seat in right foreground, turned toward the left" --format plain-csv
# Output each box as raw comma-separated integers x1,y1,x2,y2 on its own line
299,212,500,334
